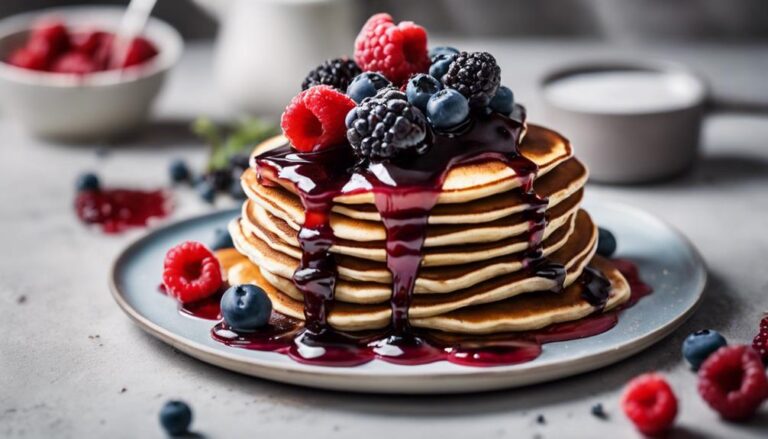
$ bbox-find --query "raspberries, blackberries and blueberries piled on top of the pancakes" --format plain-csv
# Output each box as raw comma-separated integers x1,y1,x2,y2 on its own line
281,14,514,162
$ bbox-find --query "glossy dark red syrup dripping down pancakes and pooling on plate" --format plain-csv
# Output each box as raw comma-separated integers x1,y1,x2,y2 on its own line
212,108,648,366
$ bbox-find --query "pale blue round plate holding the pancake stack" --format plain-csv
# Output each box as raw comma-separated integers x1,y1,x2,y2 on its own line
111,202,707,393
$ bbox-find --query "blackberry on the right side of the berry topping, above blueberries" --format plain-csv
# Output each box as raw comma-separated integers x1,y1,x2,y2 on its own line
442,52,501,108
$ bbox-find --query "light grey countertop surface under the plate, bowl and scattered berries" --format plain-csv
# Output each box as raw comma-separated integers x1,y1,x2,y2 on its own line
0,41,768,439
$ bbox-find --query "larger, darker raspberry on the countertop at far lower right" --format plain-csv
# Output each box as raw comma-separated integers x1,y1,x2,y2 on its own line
699,345,768,421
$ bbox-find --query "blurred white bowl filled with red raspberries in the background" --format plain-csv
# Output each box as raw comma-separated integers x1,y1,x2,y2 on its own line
0,7,183,141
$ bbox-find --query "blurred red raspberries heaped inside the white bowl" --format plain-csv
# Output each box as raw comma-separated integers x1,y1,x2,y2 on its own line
6,20,158,75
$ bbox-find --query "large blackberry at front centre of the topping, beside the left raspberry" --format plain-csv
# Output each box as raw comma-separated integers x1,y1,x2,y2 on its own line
347,87,427,161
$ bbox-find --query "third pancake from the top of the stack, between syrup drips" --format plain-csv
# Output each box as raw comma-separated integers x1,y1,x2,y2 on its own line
242,190,583,251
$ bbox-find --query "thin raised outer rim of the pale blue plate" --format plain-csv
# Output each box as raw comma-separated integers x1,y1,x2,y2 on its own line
109,205,709,394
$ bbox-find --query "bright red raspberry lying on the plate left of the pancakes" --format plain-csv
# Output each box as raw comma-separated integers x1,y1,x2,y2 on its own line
163,241,223,303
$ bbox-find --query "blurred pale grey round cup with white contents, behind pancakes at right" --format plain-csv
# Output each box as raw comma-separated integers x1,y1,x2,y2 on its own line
540,62,708,183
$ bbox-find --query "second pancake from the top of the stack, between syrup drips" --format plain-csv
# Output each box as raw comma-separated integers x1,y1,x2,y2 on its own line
241,158,588,227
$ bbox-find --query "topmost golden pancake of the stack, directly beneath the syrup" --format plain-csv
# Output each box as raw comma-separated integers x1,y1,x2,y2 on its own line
254,124,573,204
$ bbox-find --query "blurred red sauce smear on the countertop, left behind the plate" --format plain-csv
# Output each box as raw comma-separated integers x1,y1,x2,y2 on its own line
75,189,172,234
